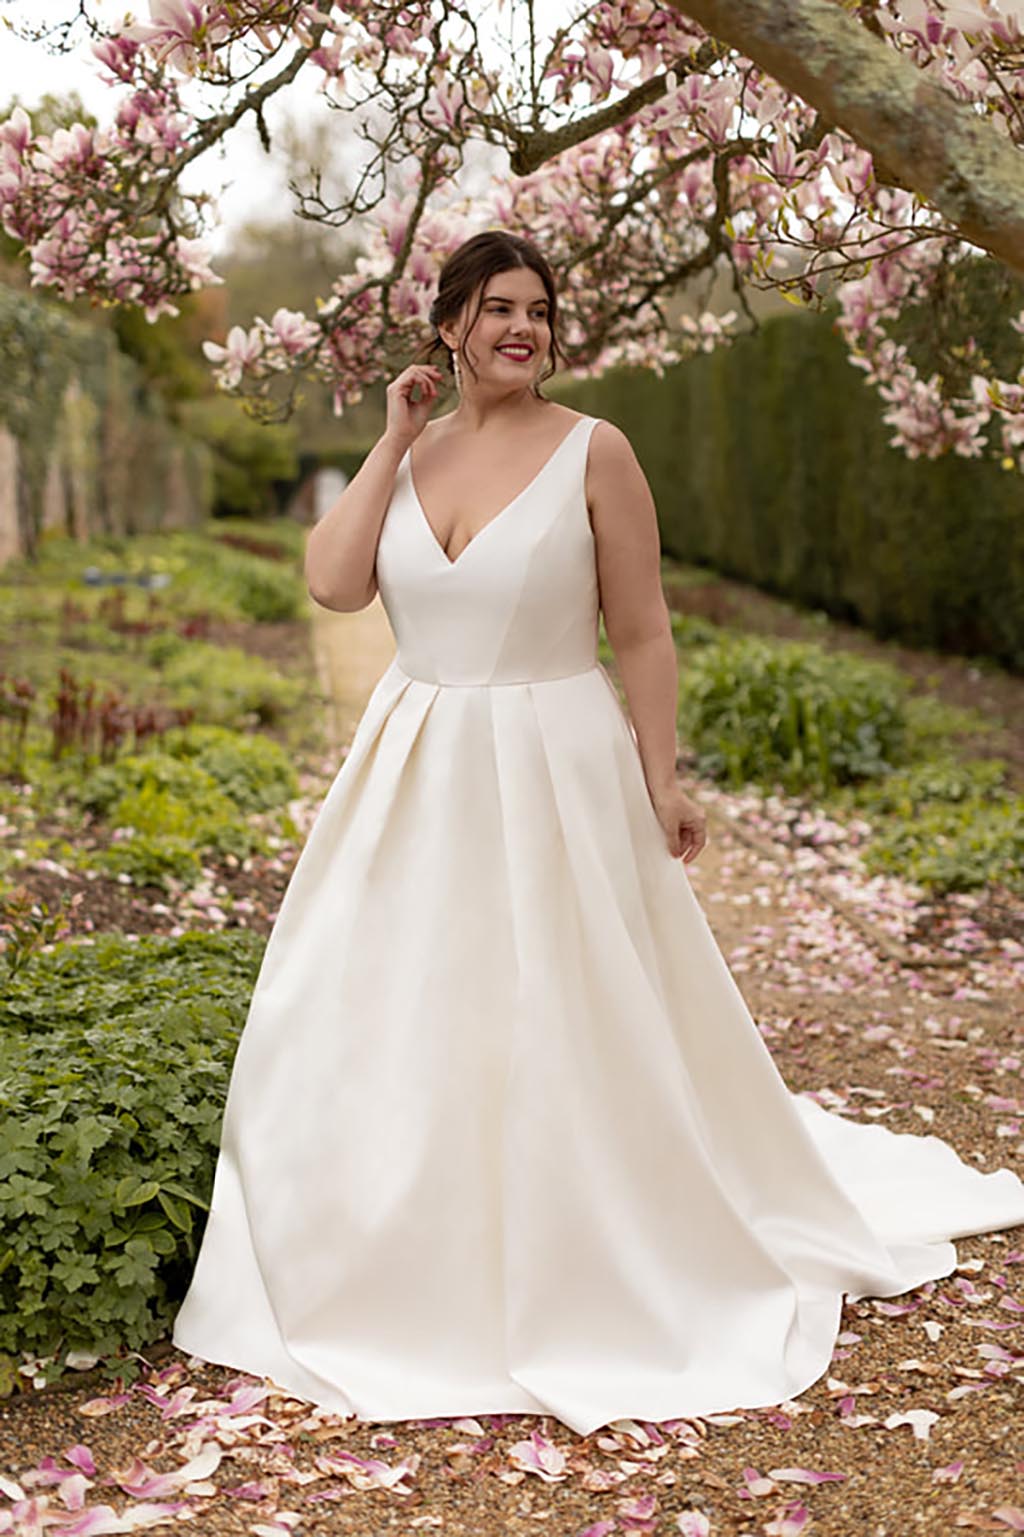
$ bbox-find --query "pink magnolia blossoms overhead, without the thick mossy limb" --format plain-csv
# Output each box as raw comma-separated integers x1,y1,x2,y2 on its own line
0,0,1024,467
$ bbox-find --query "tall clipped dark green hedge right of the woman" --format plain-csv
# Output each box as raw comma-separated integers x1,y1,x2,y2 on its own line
558,314,1024,669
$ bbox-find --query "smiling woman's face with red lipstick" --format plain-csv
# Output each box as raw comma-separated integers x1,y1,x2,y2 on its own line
440,267,552,389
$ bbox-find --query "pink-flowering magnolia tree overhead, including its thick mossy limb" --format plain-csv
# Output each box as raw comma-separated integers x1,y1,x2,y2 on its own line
0,0,1024,469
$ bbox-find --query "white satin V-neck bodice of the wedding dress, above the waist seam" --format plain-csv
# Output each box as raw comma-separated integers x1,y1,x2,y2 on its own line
377,417,598,686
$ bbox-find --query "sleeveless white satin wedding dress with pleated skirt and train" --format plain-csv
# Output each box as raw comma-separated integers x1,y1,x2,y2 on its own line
174,417,1024,1434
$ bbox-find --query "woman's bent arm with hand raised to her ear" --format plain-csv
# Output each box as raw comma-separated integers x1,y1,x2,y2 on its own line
304,363,441,613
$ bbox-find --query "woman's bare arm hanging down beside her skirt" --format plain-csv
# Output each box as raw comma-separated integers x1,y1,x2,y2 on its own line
586,421,707,862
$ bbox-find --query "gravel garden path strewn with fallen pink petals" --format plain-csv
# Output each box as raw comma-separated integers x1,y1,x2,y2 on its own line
0,593,1024,1537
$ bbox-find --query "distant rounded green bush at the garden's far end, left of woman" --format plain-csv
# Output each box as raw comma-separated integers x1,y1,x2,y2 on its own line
181,397,298,516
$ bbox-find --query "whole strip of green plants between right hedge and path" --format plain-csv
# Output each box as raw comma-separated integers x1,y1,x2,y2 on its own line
661,581,1024,896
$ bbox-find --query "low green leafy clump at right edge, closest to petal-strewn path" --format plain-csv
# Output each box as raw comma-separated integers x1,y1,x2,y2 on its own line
864,795,1024,893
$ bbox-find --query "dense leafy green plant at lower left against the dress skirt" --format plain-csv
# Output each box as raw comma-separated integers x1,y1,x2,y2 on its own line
0,930,263,1354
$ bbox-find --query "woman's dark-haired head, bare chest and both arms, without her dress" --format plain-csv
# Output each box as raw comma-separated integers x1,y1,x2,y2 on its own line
299,232,706,862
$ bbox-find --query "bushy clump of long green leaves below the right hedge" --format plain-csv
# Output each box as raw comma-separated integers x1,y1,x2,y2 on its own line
680,635,909,792
